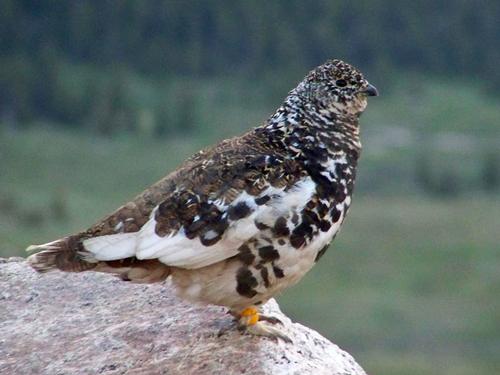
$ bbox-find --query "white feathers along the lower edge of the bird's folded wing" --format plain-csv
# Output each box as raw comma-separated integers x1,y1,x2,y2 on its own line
84,178,315,269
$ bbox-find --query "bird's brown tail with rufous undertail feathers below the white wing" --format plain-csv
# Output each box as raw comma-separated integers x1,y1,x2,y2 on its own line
26,235,171,283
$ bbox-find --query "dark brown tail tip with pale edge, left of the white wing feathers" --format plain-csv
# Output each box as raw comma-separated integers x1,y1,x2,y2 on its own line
26,235,97,272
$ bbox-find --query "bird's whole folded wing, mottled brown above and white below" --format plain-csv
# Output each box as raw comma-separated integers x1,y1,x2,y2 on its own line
84,142,313,268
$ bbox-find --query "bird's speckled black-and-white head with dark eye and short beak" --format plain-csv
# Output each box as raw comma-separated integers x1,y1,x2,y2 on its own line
296,60,378,115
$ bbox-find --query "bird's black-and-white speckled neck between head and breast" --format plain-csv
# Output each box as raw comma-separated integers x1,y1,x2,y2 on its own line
261,92,361,159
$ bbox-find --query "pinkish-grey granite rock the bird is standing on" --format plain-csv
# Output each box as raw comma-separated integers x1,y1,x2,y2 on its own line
0,260,366,375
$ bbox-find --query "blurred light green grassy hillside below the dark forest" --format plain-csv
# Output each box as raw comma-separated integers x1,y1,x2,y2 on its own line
0,83,500,375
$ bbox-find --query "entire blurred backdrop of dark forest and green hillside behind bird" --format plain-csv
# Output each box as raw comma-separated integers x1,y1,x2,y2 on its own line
0,0,500,375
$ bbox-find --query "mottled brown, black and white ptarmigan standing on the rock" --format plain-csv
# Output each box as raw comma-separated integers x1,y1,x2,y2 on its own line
27,59,378,341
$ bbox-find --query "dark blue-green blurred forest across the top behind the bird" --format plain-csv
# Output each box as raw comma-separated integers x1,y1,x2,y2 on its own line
0,0,500,134
